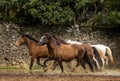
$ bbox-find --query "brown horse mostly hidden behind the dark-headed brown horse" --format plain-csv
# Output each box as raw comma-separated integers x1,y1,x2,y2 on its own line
54,36,104,70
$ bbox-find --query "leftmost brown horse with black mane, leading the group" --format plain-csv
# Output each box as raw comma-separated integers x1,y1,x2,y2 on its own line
16,35,48,70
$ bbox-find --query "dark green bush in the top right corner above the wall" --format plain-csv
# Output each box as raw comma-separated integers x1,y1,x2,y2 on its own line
92,0,120,27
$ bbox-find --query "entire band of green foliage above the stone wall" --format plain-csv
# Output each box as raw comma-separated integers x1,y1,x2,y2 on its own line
0,0,120,26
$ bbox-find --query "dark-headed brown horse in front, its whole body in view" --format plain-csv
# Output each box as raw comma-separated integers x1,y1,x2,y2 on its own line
39,34,94,72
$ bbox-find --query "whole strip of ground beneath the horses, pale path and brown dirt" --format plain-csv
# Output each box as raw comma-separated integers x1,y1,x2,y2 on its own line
0,70,120,81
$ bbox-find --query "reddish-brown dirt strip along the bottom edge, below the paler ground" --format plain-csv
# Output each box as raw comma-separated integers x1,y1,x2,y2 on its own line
0,74,120,81
